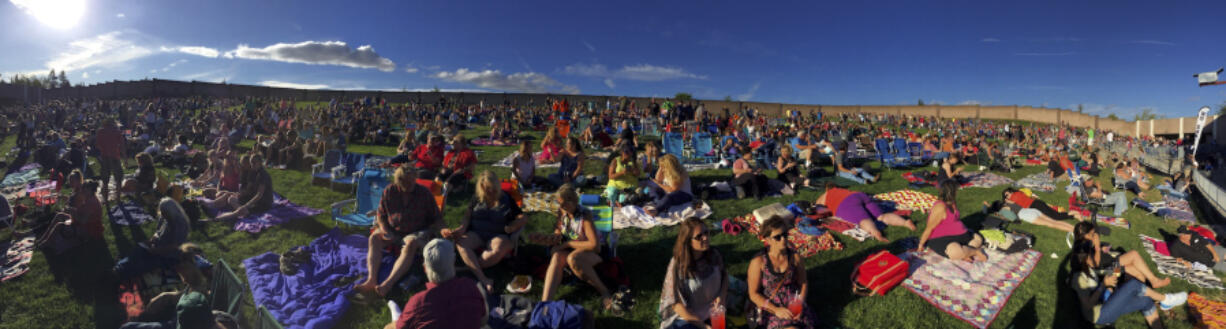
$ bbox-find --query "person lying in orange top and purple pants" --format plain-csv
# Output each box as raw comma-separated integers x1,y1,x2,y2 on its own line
814,183,916,242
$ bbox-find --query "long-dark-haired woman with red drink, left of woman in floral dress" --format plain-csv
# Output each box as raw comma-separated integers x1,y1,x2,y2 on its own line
657,217,728,329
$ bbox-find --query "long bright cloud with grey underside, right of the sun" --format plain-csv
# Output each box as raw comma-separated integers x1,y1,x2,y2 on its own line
224,41,396,72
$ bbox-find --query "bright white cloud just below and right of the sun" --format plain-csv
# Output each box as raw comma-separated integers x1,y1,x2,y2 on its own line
47,31,153,71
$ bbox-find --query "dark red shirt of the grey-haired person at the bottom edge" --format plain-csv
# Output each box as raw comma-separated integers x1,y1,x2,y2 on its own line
396,277,487,329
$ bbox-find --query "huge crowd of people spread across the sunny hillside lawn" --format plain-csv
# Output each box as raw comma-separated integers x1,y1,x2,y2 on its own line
0,93,1226,328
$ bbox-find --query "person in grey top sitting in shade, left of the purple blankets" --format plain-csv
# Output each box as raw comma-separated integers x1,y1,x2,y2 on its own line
114,198,191,281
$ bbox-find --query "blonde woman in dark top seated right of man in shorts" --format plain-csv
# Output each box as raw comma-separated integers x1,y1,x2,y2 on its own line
440,171,528,291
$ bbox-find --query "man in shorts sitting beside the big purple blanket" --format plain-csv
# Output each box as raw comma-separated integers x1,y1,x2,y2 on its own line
354,167,444,296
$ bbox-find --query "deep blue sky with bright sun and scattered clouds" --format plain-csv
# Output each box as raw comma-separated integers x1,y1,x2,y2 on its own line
0,0,1226,119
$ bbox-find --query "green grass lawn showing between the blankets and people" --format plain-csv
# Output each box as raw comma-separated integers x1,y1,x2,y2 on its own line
0,129,1226,328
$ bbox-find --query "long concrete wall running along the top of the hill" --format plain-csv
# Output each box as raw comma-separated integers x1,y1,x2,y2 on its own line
0,80,1206,137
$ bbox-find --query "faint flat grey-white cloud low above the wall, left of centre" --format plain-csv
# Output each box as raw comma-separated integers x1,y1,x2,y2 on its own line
434,69,579,93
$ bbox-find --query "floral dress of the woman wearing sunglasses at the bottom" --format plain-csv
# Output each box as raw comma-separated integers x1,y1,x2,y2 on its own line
750,250,818,329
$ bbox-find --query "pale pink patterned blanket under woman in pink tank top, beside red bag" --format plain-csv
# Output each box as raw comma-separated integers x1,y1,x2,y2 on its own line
902,250,1042,329
